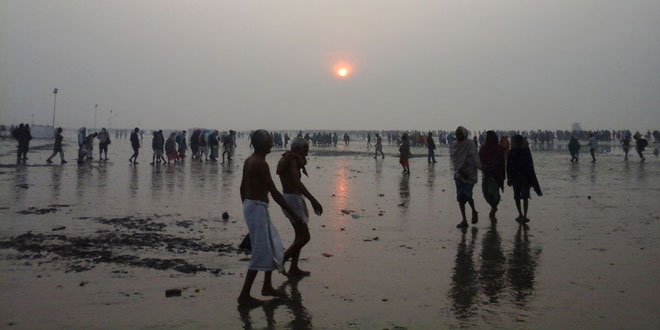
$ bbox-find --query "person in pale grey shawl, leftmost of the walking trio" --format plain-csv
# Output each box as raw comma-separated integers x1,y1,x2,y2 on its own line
450,126,481,228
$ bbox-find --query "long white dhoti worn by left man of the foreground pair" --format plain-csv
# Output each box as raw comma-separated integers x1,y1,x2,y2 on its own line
243,199,284,272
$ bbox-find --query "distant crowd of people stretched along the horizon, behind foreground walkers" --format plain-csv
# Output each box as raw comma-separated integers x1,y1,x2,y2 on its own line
10,124,660,166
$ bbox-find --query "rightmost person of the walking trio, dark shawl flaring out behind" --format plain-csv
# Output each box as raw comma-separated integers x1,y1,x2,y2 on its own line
506,135,543,223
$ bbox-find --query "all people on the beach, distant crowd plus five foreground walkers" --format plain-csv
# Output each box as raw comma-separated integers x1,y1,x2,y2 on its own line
3,124,660,307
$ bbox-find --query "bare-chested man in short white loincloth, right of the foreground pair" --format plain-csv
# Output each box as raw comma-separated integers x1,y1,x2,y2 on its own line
277,138,323,277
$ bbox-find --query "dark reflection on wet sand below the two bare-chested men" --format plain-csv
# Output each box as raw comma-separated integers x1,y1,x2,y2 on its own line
238,277,314,329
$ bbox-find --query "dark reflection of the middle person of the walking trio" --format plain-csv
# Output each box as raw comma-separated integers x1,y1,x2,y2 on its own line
479,223,506,303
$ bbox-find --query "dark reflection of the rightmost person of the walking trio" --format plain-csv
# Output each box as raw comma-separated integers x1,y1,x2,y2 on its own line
507,225,541,307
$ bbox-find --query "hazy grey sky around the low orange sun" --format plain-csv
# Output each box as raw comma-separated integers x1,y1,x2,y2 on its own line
0,0,660,129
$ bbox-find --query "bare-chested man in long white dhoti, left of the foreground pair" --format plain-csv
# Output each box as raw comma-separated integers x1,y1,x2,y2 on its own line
238,130,302,307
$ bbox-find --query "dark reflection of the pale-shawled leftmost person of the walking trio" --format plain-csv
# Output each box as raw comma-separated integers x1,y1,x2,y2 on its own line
449,228,478,319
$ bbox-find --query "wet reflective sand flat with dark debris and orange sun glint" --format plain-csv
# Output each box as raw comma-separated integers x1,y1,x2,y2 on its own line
0,140,660,329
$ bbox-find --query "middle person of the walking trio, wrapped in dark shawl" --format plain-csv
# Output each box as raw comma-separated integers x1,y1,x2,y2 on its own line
479,131,505,221
